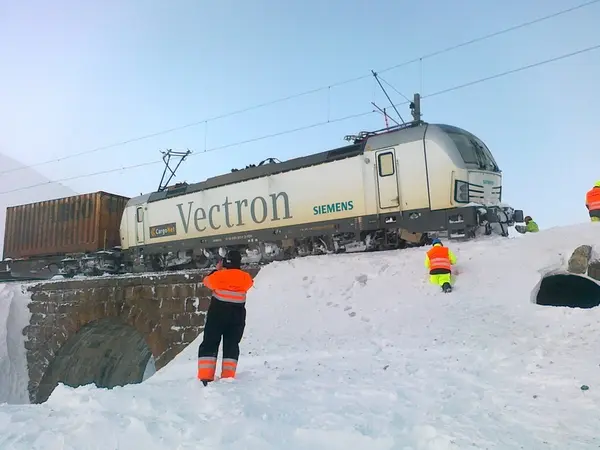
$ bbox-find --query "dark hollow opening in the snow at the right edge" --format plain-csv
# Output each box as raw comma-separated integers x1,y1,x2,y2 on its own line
535,273,600,309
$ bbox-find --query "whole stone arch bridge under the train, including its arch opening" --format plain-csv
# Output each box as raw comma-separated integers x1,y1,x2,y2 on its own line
23,269,259,403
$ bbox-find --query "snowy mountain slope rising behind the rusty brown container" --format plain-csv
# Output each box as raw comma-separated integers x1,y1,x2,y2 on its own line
0,153,76,256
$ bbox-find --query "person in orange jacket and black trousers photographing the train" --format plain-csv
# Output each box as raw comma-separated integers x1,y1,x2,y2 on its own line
198,250,254,386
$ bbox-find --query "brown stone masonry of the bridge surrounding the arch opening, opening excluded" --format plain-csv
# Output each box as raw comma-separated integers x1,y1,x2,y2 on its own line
23,269,259,402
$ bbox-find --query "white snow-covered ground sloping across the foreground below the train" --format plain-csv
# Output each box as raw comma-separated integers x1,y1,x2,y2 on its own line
0,224,600,450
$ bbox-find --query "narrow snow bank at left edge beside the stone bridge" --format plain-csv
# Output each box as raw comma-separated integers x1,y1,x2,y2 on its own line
0,283,31,404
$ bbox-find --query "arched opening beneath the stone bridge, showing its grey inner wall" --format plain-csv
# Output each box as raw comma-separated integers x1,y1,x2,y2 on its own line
35,318,155,403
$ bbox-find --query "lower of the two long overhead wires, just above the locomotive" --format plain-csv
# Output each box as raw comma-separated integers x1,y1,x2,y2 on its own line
0,44,600,194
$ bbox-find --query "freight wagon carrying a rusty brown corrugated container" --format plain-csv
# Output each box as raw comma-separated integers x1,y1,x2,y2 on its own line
4,191,129,278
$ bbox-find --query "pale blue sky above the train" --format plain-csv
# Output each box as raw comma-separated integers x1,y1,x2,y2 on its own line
0,0,600,228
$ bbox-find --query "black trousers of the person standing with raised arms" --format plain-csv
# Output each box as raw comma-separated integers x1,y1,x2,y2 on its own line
198,297,246,361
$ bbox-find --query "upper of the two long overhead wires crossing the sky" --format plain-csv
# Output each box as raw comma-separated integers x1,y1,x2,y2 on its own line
0,0,600,175
